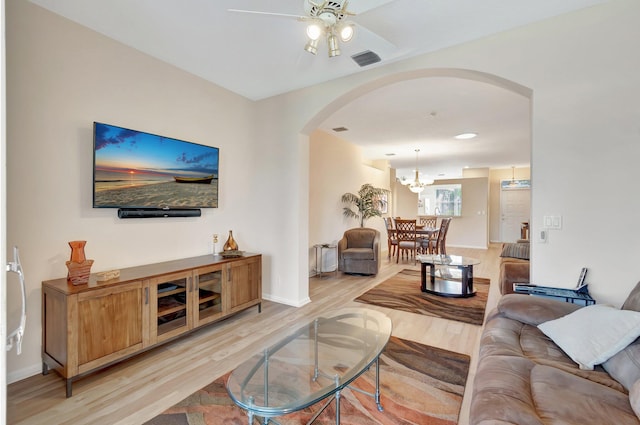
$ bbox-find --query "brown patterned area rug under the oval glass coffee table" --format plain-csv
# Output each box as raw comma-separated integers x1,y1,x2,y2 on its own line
145,337,470,425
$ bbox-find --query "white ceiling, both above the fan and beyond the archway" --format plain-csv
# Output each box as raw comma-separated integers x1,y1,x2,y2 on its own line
31,0,607,178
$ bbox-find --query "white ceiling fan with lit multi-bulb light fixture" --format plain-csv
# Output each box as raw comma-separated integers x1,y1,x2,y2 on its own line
228,0,378,57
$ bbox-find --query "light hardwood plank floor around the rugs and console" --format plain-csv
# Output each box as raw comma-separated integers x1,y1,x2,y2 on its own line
7,245,500,425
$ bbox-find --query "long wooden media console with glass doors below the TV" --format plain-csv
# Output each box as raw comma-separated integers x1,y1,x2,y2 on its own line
42,254,262,397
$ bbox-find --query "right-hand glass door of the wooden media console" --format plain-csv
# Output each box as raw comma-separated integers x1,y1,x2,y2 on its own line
194,266,223,325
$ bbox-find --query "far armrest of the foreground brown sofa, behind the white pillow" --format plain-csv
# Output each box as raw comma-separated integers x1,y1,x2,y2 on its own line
497,294,582,326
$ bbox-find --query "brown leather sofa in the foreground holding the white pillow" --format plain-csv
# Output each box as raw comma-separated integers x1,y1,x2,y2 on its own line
470,283,640,425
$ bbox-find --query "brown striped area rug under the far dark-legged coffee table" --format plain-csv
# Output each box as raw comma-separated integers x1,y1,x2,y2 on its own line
354,269,489,325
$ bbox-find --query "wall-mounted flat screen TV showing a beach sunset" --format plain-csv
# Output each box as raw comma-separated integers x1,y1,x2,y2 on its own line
93,122,220,209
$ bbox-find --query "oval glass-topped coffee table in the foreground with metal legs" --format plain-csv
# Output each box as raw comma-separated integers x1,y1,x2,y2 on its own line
226,308,392,425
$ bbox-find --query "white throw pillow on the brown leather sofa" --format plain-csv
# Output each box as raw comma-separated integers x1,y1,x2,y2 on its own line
538,304,640,370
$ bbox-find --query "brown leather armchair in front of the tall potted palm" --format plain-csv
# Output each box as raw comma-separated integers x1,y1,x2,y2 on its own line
338,227,380,275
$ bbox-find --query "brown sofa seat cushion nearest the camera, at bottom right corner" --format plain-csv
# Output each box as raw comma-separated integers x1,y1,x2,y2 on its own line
530,365,638,425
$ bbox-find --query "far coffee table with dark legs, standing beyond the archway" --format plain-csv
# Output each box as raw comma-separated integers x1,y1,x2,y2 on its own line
416,254,480,298
